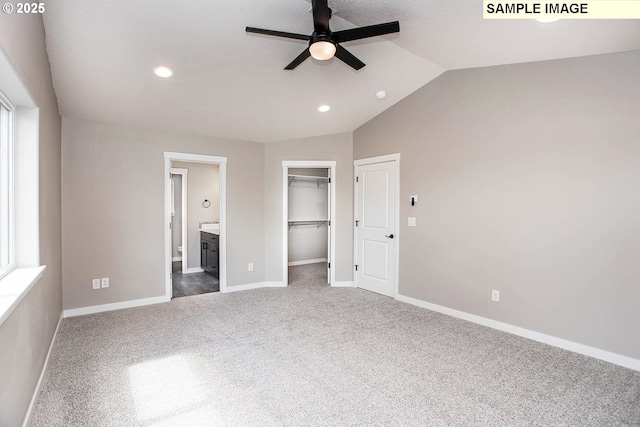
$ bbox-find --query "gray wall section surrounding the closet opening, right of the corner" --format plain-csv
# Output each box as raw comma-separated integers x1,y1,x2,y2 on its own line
264,133,353,281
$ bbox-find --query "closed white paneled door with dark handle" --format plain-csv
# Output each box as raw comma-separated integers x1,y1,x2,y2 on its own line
356,161,398,297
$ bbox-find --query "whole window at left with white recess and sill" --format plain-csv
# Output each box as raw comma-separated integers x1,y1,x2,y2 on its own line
0,46,47,325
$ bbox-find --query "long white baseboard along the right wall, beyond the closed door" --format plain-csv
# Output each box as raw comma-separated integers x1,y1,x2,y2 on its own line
396,294,640,371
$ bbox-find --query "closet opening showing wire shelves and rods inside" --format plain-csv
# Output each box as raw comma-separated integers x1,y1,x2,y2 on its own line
283,161,335,285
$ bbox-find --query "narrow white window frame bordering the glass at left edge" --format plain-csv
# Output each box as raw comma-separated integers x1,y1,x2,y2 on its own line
0,91,16,278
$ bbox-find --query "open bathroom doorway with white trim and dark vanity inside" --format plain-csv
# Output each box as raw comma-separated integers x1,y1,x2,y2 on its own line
164,152,227,299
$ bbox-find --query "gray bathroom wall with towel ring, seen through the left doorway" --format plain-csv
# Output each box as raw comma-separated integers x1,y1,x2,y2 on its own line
172,162,220,268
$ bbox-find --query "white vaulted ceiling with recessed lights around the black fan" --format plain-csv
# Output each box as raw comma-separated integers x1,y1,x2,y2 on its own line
43,0,640,142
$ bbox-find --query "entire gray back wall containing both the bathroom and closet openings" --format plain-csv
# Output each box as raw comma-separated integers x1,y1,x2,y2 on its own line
62,123,353,309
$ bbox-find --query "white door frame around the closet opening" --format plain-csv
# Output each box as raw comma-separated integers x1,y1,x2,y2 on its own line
282,160,337,286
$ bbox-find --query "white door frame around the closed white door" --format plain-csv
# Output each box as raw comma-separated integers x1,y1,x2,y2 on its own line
353,153,401,298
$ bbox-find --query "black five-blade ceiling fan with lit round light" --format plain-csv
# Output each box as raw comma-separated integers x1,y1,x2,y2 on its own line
246,0,400,70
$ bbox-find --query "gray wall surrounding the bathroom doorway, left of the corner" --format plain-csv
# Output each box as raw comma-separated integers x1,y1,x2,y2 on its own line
62,118,265,309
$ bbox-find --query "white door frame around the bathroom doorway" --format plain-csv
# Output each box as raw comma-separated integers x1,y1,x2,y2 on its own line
163,151,227,299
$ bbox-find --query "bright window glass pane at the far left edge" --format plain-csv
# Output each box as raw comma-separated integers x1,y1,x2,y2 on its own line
0,93,15,277
